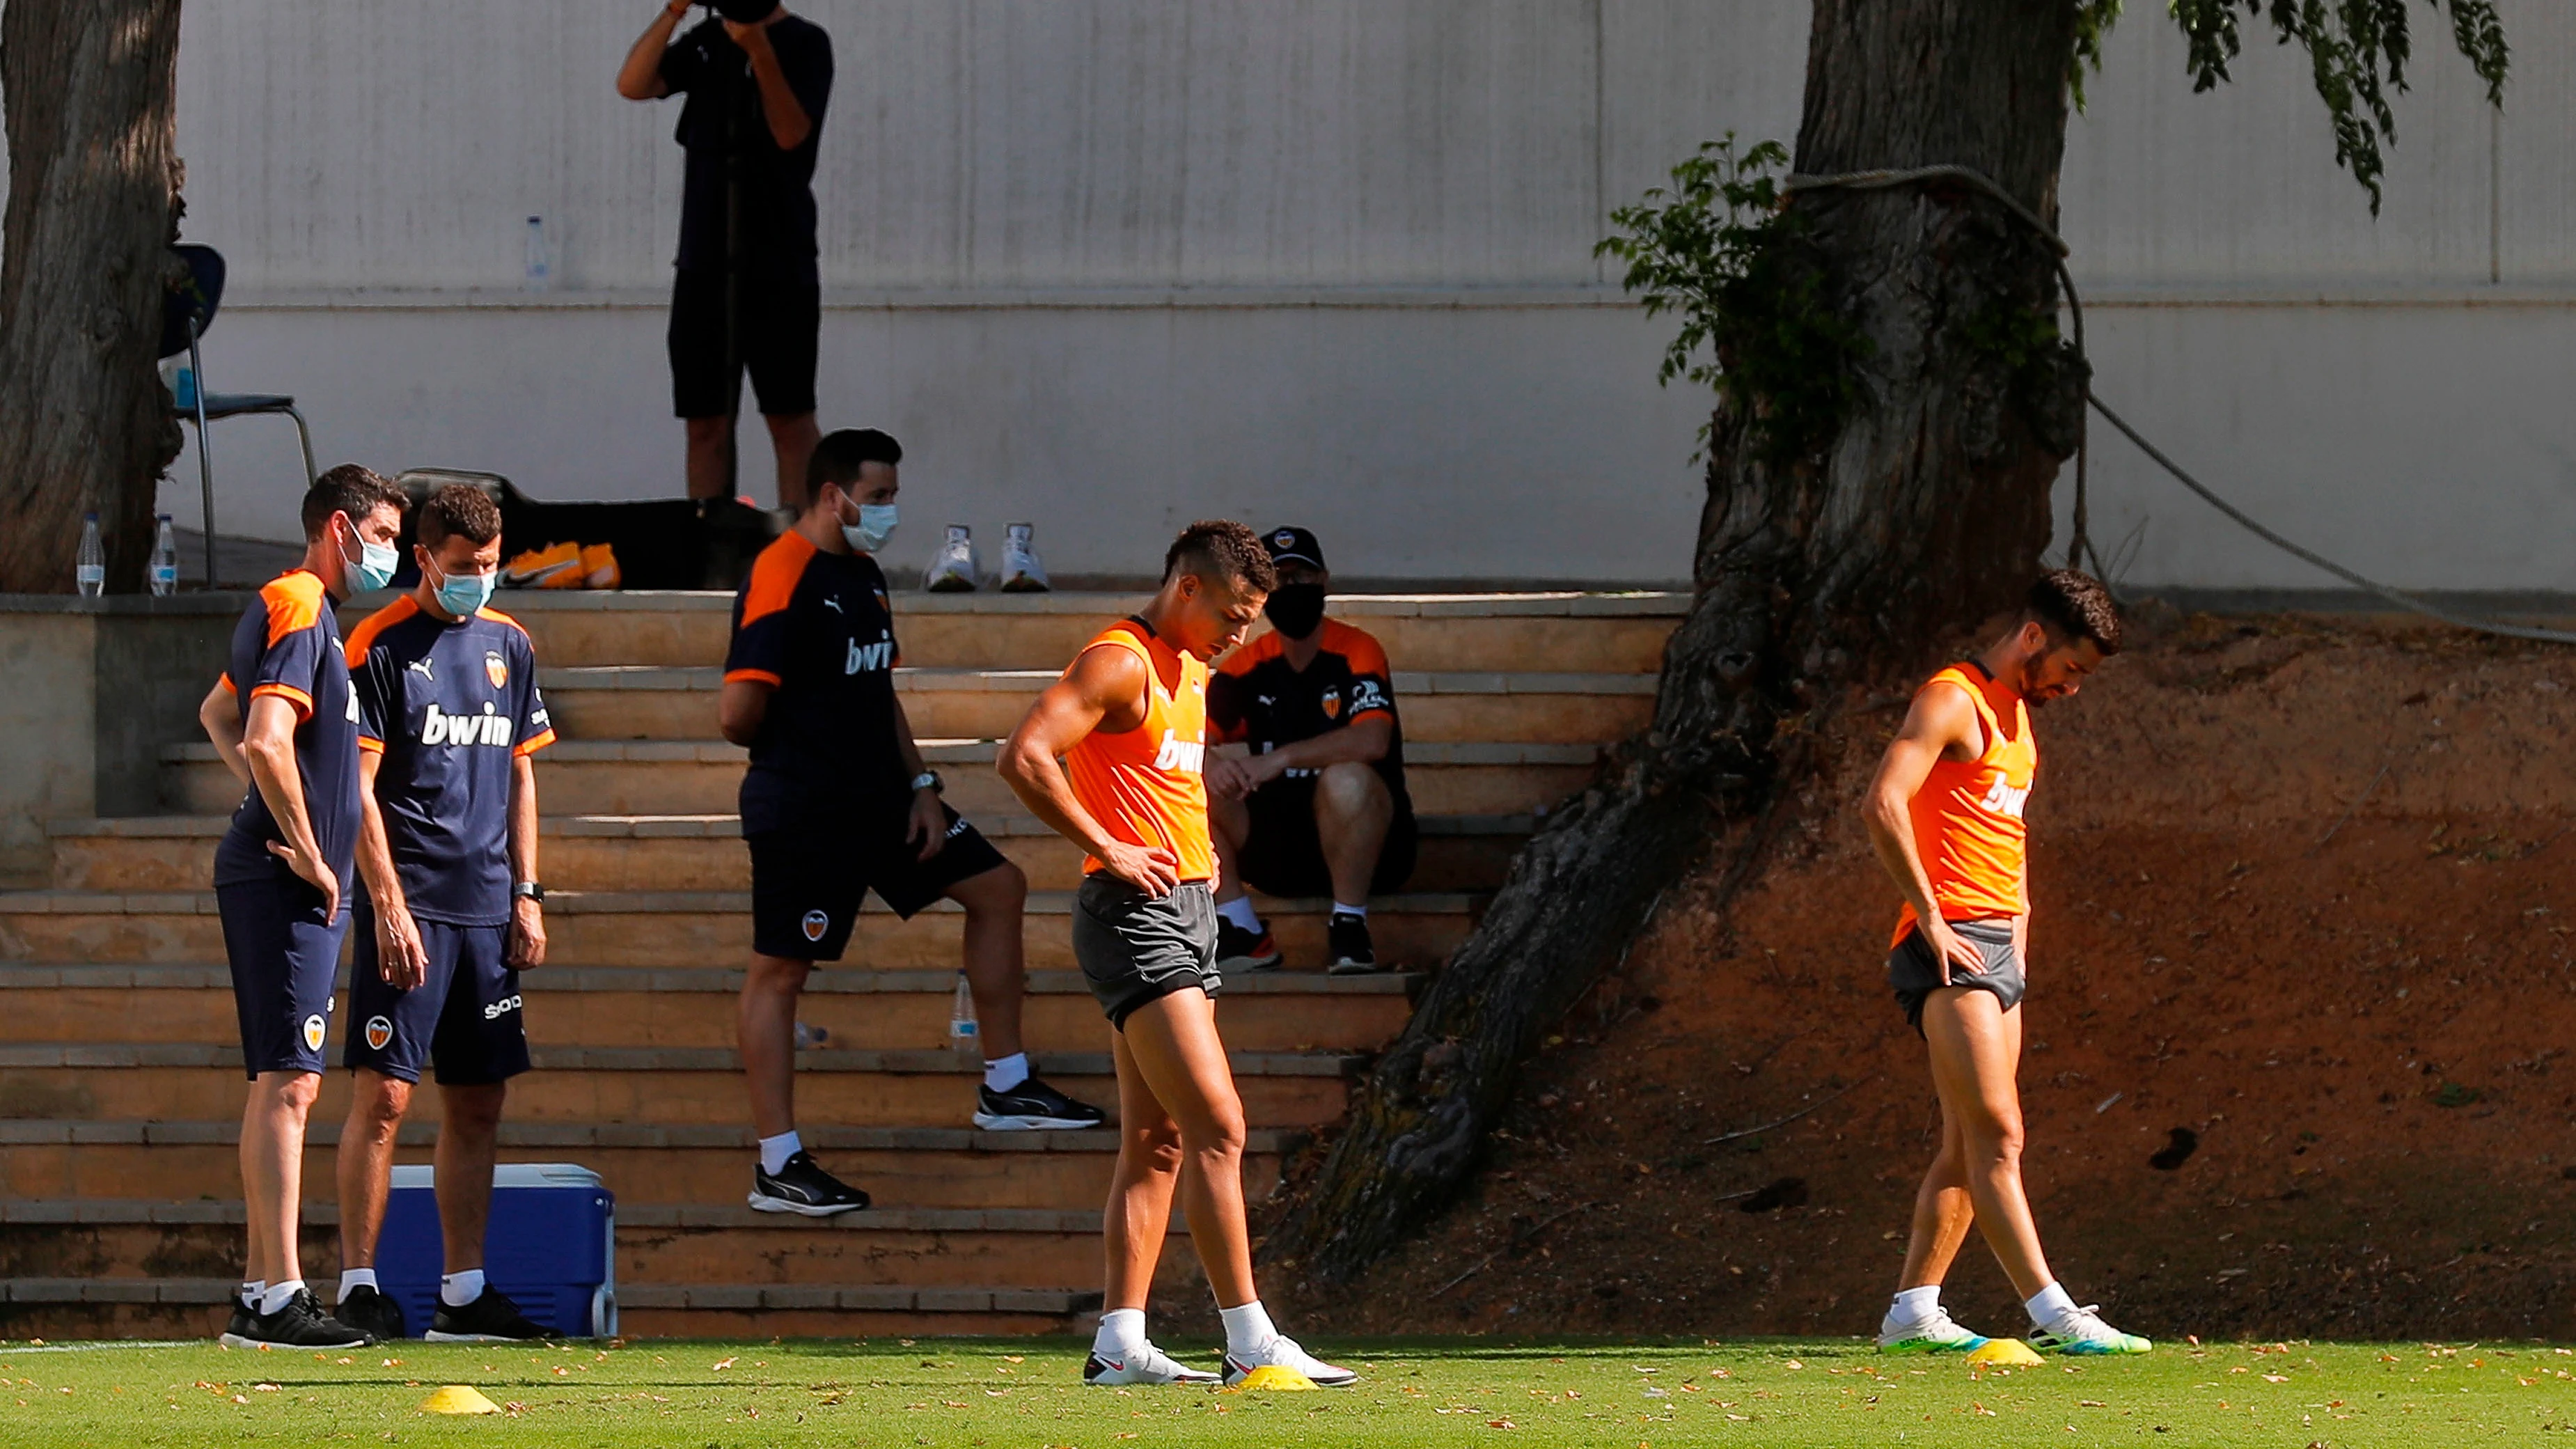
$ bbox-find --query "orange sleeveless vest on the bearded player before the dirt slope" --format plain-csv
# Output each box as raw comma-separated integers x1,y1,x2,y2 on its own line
1891,665,2040,943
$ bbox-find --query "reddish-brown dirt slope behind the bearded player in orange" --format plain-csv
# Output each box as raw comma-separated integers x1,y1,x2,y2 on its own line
1278,608,2576,1338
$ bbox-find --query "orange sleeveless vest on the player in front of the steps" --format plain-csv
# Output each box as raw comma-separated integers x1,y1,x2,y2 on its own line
1064,619,1216,882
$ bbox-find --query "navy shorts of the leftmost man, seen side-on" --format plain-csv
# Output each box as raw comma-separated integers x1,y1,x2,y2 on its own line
214,866,348,1080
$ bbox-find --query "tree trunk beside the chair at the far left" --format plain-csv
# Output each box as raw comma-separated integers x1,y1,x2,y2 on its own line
0,0,180,593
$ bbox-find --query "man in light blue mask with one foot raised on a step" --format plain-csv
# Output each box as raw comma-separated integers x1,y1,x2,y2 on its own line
718,428,1103,1217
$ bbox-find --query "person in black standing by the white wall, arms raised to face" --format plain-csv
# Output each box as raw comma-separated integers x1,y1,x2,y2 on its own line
618,0,832,508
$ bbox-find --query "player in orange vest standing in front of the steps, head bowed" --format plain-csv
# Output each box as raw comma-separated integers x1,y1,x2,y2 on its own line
997,524,1355,1387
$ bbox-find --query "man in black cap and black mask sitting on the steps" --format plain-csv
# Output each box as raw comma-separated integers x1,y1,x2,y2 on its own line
1208,528,1417,975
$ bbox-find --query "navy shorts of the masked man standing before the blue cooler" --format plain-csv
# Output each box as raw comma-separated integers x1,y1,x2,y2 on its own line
340,900,528,1086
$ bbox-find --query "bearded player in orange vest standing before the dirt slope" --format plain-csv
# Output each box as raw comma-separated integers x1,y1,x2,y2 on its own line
1862,570,2151,1354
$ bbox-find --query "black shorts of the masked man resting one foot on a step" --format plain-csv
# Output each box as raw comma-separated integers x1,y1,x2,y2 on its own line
750,797,1005,962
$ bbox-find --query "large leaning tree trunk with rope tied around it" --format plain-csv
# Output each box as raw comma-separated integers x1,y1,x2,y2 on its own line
1262,0,2084,1281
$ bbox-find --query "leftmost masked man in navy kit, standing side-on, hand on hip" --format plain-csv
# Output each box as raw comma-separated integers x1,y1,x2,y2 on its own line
196,464,402,1349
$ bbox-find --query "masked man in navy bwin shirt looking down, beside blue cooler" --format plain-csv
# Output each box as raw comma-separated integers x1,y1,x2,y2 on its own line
338,482,554,1340
